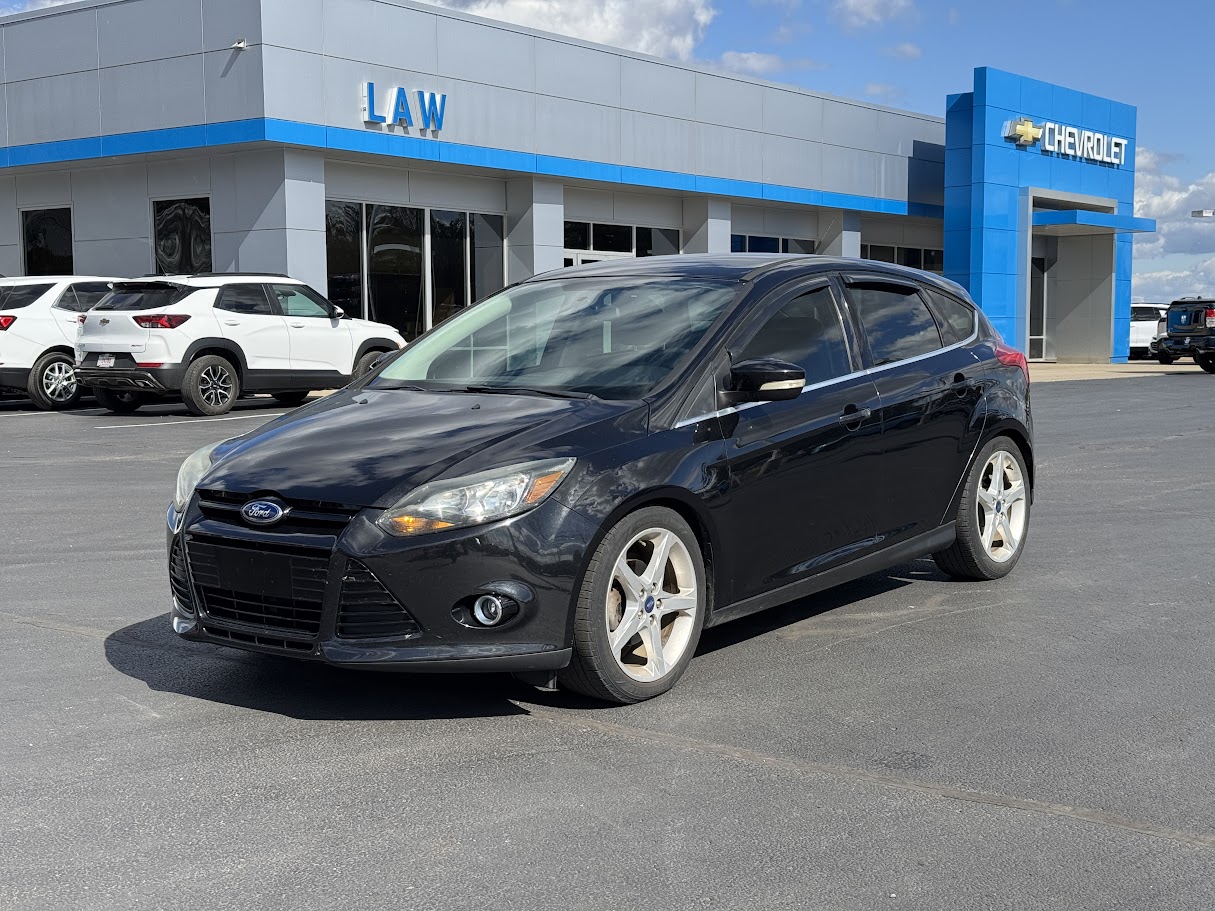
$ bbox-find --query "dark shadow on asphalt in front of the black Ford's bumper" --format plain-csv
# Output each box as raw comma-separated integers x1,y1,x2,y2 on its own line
104,613,527,720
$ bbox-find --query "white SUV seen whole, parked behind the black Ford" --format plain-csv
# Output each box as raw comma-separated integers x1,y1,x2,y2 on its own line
75,273,405,414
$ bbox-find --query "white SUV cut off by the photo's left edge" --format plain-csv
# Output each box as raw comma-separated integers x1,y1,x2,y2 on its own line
0,276,114,411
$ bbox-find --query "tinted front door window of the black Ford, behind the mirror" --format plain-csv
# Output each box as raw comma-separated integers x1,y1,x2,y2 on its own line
736,287,855,386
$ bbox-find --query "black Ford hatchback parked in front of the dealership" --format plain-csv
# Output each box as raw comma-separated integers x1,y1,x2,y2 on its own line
168,254,1033,702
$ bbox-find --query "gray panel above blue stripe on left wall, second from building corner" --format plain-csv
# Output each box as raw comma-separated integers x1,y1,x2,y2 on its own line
94,53,204,134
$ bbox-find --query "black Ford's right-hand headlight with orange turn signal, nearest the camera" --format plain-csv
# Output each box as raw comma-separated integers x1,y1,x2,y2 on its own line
379,459,575,538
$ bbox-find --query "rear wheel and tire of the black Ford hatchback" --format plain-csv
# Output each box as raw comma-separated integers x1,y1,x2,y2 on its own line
932,436,1030,582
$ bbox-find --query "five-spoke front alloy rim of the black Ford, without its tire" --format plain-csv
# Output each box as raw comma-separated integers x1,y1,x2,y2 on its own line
604,528,700,683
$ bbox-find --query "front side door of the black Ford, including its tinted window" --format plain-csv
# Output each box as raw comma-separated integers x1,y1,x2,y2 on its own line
723,277,881,600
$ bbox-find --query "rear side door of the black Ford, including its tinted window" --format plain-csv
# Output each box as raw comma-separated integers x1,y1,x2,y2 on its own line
842,273,985,544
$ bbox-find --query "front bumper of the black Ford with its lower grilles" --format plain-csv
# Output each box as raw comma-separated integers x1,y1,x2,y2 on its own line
168,497,598,673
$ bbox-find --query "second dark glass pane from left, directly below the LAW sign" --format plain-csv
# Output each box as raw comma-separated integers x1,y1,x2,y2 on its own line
365,205,426,341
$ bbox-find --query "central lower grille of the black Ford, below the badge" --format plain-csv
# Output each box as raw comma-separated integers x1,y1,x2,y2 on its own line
186,534,329,641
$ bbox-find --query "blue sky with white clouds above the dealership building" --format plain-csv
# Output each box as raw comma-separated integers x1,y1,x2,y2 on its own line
0,0,1215,299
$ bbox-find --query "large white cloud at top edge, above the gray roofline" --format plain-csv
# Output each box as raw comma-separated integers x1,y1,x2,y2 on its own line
431,0,717,61
